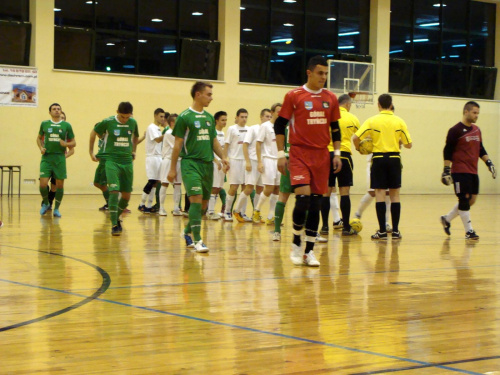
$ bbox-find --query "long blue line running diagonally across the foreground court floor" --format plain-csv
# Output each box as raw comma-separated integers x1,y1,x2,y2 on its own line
0,279,483,375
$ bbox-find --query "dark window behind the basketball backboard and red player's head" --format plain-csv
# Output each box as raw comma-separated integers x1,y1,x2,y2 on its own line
240,0,370,85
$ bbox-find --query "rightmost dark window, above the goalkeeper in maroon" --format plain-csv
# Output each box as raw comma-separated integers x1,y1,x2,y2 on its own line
389,0,496,99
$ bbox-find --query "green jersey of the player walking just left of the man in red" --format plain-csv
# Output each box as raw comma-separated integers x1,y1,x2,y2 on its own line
172,108,217,162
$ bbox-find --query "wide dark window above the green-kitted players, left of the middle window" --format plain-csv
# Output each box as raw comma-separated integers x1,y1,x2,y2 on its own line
54,0,220,79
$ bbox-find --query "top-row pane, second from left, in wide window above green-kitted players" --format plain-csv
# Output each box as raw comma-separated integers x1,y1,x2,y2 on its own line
95,0,137,31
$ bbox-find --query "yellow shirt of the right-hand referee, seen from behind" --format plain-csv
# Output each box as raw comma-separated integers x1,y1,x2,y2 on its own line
356,110,411,152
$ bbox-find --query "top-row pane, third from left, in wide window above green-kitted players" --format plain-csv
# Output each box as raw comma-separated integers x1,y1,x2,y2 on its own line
139,0,178,35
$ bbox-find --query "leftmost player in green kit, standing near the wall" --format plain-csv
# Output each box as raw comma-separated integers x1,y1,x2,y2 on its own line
36,103,76,217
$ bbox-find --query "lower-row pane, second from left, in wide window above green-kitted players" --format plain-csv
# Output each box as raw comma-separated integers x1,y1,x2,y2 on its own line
95,33,137,73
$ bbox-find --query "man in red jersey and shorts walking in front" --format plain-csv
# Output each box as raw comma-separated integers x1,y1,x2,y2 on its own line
274,56,342,267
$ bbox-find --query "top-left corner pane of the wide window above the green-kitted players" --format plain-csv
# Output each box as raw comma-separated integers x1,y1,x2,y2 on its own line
54,0,94,28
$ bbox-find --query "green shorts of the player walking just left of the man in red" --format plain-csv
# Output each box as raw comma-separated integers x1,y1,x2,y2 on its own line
181,159,214,201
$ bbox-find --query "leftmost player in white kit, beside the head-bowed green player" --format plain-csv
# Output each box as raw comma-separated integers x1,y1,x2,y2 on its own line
139,108,165,214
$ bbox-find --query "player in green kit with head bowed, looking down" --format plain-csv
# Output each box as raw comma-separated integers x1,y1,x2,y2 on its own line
89,102,139,236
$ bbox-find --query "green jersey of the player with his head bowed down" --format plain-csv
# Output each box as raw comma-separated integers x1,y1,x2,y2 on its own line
94,116,139,164
